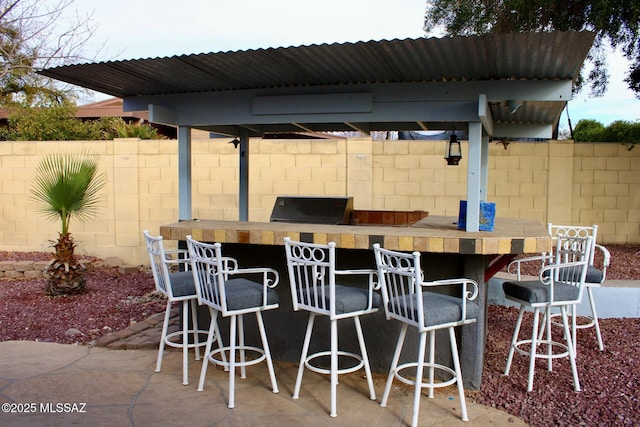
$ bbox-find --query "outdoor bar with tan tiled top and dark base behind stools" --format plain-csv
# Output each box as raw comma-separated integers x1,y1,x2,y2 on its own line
160,216,551,390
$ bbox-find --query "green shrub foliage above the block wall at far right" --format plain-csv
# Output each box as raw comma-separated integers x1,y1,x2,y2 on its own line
573,120,640,147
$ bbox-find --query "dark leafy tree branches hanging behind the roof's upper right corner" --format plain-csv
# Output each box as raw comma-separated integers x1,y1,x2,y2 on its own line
424,0,640,98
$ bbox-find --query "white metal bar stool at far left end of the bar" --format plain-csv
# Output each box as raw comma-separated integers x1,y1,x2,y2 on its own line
143,230,208,385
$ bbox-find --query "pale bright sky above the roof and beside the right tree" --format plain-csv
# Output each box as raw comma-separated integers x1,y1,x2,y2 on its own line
62,0,640,128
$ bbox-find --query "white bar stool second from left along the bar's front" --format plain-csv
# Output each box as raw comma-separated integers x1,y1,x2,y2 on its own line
187,236,279,408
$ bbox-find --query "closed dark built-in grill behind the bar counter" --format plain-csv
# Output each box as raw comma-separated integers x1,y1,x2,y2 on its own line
271,196,353,225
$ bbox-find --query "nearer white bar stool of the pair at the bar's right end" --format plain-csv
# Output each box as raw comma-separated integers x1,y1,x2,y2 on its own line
502,235,592,391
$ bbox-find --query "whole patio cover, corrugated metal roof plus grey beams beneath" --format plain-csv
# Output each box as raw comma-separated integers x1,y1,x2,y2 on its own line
40,31,594,136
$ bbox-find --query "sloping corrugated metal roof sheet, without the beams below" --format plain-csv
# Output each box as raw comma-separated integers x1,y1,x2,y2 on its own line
40,32,593,98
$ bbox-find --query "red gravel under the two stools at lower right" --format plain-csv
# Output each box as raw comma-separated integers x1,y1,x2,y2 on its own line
468,305,640,427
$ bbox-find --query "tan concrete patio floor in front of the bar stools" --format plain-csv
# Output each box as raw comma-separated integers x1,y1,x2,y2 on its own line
0,341,526,427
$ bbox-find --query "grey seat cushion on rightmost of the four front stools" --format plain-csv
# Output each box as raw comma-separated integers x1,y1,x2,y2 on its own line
389,291,480,326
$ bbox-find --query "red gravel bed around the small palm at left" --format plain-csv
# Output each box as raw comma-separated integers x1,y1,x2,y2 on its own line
0,252,166,344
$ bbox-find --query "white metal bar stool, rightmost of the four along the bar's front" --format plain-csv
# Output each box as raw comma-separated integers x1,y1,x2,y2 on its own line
373,243,479,426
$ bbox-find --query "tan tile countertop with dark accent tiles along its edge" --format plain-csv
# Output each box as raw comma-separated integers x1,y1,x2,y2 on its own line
160,216,551,256
